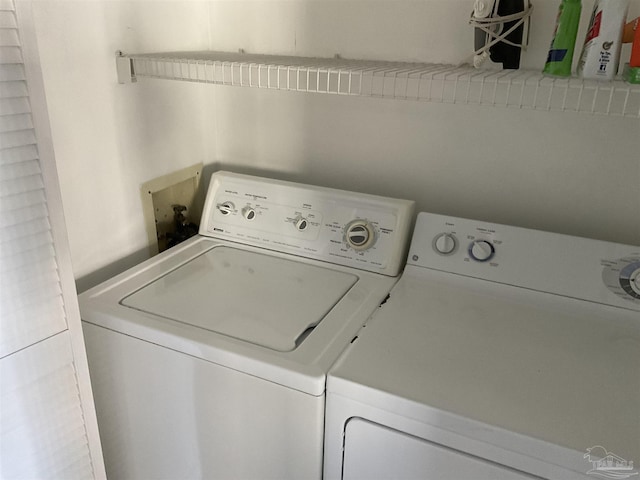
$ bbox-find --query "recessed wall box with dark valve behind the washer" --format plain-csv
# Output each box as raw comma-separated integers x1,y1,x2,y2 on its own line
141,164,203,255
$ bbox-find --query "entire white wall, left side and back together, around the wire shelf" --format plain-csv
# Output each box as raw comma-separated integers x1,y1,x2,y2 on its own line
32,0,640,288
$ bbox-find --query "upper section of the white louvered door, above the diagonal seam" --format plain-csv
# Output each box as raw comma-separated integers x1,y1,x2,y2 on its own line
0,1,67,357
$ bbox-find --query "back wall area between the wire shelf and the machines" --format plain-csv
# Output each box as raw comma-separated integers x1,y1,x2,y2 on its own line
211,91,640,244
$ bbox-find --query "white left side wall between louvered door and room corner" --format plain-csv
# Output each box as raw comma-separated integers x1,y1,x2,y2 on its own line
30,0,215,287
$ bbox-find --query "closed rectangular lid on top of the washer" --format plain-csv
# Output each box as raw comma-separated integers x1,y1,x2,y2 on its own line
121,247,357,352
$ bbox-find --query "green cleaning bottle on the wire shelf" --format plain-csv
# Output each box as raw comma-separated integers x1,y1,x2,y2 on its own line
542,0,582,77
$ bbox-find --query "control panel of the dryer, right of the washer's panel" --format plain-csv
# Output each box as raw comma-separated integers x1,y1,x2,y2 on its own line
407,212,640,311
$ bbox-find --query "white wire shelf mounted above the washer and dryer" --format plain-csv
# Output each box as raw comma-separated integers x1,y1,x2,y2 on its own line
116,51,640,118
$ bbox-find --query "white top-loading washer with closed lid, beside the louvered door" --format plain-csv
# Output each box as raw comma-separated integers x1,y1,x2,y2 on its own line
80,172,413,479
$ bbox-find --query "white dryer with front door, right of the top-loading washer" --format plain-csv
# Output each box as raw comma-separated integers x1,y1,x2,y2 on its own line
325,213,640,480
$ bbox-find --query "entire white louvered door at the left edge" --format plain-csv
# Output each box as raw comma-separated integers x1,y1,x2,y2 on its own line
0,0,105,480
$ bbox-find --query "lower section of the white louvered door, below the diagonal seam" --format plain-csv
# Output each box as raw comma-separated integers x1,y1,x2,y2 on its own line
0,332,94,480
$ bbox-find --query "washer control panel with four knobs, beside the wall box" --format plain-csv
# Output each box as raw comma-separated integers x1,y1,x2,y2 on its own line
200,172,414,276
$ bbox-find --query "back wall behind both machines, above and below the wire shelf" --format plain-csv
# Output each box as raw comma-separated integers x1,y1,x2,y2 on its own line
211,0,640,244
